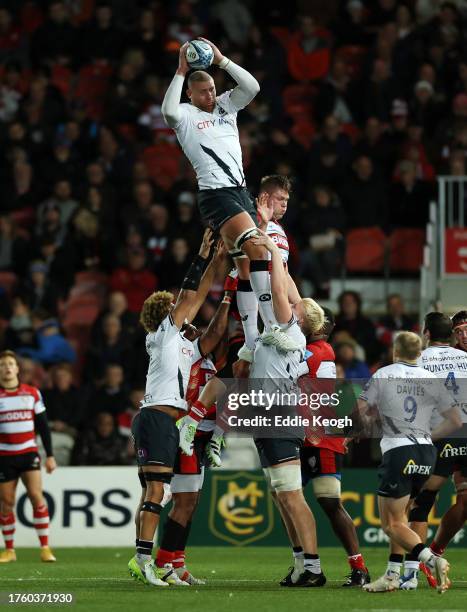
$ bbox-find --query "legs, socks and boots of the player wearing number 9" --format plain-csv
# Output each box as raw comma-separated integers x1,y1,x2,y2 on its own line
363,495,450,593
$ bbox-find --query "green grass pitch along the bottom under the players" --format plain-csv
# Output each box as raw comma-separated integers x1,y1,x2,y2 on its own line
0,547,467,612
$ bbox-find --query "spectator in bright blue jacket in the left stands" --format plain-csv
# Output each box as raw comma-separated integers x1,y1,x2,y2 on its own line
18,310,76,366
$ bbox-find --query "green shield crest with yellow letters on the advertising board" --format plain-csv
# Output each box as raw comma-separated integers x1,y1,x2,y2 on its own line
208,472,274,546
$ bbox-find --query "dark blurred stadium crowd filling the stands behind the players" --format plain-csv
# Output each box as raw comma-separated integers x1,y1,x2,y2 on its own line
0,0,467,465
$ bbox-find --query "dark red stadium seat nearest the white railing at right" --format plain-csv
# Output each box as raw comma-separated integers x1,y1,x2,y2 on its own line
389,228,425,273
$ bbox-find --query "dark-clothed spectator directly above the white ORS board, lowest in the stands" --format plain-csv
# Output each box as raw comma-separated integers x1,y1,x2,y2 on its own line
72,412,128,465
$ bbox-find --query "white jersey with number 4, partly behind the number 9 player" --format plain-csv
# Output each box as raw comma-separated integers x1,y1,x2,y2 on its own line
418,344,467,429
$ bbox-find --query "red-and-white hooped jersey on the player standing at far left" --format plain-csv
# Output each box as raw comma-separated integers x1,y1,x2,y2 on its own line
0,385,45,456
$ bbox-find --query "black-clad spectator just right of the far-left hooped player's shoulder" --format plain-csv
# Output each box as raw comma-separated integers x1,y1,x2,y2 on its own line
43,363,84,438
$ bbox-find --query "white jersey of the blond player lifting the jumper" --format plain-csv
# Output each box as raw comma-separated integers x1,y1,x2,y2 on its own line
250,315,306,391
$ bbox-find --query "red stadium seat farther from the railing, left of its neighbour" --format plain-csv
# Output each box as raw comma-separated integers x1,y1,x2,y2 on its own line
345,227,386,272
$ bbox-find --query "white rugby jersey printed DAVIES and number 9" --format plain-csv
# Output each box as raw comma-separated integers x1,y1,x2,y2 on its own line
360,362,456,453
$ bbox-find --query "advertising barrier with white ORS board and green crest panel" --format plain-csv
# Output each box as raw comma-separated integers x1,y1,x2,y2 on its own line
12,467,467,547
